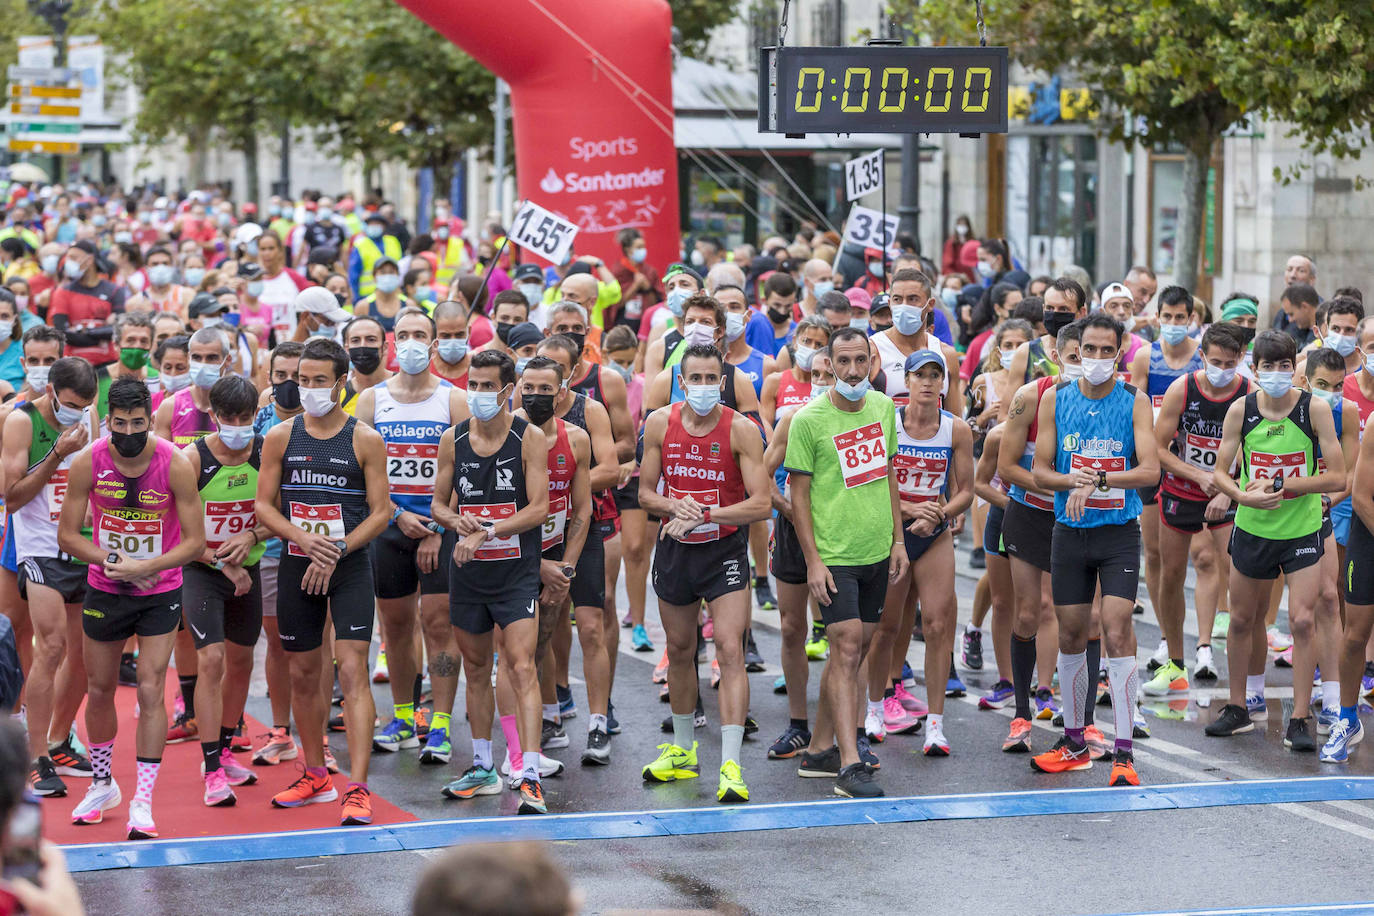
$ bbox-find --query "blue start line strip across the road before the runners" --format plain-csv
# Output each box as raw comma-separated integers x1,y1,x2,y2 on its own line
63,776,1374,873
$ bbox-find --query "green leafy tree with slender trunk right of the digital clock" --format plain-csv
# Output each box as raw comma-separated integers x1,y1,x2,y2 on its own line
889,0,1374,288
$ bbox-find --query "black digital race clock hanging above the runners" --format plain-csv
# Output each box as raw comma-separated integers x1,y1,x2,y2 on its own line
758,45,1007,133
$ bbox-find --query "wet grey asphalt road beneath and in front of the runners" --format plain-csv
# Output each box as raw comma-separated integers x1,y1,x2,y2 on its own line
69,538,1374,916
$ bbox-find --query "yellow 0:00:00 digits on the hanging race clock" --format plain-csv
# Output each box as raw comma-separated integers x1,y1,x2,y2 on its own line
793,67,992,114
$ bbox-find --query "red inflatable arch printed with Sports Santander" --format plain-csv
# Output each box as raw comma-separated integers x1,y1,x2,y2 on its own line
398,0,680,266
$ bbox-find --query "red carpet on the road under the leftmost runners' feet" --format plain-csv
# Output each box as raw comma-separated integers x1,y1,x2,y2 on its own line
43,677,416,845
